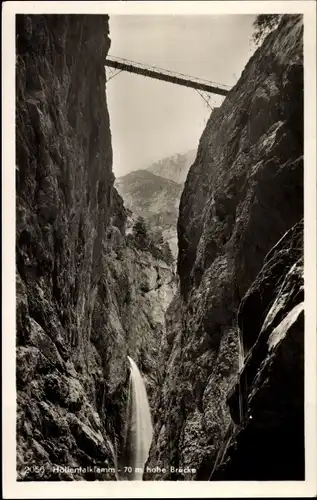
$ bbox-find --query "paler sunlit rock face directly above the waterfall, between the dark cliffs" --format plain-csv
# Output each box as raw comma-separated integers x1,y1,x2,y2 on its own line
91,191,177,413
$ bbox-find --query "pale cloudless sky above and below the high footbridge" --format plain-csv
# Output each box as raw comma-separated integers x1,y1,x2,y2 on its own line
107,15,255,177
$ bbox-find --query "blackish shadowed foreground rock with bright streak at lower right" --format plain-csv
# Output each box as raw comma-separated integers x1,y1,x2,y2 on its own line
212,222,305,481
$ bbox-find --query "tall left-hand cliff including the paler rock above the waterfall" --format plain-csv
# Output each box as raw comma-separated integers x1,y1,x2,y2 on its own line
16,15,174,480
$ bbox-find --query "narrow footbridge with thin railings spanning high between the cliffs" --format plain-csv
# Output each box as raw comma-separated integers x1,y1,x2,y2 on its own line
105,56,230,96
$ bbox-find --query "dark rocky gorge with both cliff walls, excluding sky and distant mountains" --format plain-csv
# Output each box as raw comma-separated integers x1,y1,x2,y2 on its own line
16,14,305,481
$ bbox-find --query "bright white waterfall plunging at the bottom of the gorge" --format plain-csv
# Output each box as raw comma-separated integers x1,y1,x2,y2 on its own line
126,356,153,481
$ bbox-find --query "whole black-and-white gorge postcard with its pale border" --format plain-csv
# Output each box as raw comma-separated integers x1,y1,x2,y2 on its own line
3,1,316,498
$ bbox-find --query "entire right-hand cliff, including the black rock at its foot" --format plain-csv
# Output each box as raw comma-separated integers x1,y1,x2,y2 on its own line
145,16,304,480
